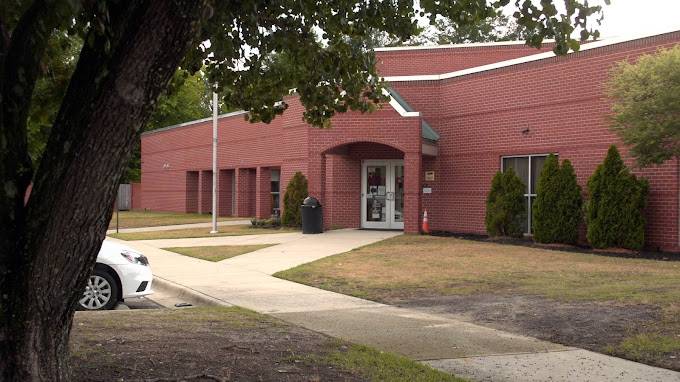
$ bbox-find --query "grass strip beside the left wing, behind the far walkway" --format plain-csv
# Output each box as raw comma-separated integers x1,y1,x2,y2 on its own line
109,210,248,229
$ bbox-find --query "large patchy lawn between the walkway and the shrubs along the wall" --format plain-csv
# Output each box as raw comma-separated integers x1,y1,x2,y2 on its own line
275,235,680,370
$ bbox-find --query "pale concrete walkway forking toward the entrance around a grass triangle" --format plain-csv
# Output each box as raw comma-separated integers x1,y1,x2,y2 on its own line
114,230,680,381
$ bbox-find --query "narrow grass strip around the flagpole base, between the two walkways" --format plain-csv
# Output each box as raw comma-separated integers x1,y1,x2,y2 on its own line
109,225,296,240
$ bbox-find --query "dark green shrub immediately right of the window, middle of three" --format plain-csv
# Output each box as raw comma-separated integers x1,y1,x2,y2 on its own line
531,154,583,244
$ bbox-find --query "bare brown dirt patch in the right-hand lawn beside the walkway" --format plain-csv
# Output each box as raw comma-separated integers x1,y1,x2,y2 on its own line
394,294,680,370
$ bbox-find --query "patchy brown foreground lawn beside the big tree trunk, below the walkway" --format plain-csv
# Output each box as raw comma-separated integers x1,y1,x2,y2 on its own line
70,307,461,382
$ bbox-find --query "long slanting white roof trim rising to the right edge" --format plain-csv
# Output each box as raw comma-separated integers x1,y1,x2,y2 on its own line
382,30,680,82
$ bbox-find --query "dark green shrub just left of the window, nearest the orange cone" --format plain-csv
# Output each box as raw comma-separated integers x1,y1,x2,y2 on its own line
485,168,526,237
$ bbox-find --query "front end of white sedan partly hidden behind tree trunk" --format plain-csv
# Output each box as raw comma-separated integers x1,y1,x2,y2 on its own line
78,240,153,310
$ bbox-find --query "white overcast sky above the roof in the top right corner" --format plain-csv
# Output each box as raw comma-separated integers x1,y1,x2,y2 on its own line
598,0,680,37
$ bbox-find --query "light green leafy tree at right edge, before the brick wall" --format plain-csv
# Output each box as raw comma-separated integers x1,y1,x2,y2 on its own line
608,46,680,166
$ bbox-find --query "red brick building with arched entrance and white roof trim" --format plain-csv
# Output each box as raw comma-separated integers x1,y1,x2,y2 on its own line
142,32,680,251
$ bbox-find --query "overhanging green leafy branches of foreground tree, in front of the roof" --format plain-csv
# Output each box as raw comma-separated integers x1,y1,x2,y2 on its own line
183,0,601,126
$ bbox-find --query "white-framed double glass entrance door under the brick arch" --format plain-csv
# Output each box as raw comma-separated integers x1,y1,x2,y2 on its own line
361,160,404,229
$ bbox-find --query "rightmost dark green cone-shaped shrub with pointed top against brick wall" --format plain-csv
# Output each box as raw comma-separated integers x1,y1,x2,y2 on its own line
586,145,649,250
